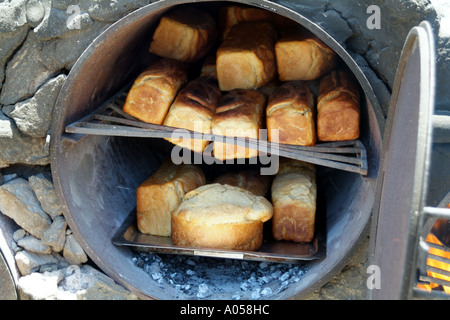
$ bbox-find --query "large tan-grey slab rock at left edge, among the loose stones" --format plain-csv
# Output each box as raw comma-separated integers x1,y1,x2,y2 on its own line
0,178,52,239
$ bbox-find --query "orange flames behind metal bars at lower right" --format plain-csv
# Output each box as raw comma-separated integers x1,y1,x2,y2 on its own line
417,204,450,294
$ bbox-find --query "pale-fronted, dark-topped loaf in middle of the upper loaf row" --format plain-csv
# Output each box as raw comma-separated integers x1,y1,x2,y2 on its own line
216,22,277,91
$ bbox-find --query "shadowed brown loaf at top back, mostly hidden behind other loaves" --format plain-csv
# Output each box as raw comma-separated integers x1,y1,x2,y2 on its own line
219,5,296,39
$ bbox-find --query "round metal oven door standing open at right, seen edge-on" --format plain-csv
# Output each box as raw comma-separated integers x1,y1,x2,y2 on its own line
367,22,436,299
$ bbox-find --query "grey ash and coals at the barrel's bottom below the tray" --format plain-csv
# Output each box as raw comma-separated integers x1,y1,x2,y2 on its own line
133,252,306,300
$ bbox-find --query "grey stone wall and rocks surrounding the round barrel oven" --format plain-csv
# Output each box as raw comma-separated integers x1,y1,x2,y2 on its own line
0,0,450,299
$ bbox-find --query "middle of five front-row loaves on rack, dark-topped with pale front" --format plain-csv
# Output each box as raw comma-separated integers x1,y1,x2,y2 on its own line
211,89,267,161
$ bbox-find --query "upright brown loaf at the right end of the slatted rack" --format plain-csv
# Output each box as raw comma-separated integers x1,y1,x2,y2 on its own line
317,70,360,141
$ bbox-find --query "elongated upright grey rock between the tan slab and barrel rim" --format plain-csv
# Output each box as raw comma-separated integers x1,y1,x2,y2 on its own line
28,173,62,220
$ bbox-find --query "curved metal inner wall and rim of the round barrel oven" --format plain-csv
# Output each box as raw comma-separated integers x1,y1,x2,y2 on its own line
51,2,381,299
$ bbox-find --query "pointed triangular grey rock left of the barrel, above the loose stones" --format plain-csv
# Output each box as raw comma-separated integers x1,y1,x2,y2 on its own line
10,74,66,138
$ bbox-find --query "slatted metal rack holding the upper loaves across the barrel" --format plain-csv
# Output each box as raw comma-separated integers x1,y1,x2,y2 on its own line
66,85,368,175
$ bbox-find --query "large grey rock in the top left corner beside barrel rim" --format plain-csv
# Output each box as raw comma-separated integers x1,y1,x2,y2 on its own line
0,1,110,105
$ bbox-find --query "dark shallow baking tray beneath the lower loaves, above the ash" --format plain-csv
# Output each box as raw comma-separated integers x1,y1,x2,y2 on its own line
112,210,326,263
